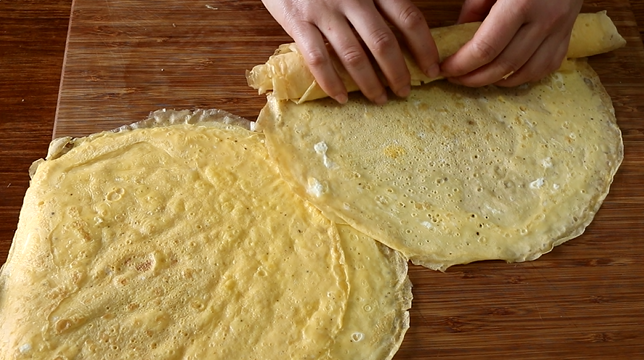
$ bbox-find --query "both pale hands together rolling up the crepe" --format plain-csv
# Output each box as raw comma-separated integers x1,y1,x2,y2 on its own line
262,0,583,104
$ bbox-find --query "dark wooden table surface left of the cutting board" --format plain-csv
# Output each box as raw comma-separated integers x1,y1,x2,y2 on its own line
0,0,71,268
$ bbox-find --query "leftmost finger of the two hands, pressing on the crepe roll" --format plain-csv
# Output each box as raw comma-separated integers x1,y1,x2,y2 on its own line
289,23,348,104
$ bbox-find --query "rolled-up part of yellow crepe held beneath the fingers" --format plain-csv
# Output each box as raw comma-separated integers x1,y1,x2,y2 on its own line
246,11,626,103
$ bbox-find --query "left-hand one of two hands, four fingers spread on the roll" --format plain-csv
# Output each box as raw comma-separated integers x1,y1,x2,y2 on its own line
262,0,440,104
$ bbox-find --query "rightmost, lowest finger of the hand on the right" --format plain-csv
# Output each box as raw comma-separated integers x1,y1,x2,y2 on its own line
495,36,570,87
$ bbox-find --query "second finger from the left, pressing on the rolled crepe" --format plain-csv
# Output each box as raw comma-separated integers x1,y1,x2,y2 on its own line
318,19,387,104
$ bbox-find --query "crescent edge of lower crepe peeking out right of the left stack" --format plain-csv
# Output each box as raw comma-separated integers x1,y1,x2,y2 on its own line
329,225,411,360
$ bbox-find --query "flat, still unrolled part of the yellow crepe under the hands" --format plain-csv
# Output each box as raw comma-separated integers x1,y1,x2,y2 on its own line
258,60,623,270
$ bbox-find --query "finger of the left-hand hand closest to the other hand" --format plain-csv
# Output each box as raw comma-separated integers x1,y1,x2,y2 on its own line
376,0,440,78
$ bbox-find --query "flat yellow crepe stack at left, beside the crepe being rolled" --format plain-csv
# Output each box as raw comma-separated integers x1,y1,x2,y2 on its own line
0,110,411,359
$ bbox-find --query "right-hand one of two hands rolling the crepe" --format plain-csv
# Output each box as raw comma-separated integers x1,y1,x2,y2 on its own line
441,0,583,86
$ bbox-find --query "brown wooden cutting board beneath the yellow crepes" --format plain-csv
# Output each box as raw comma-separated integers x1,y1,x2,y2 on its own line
54,0,644,359
